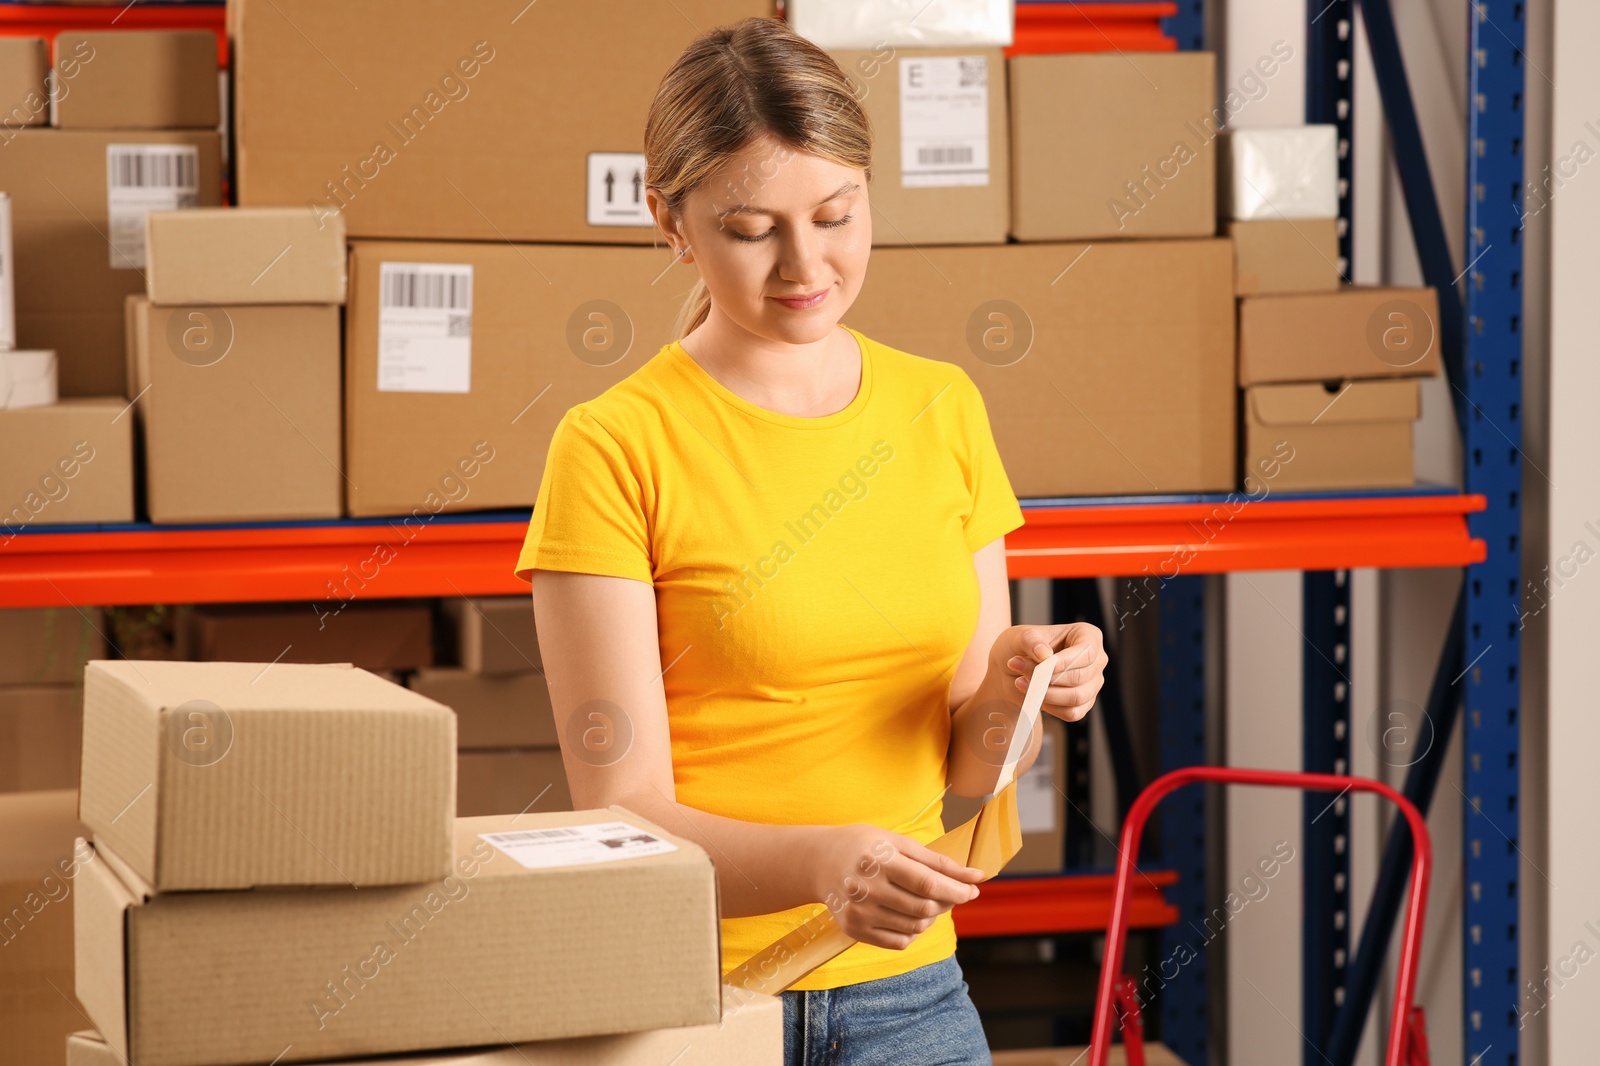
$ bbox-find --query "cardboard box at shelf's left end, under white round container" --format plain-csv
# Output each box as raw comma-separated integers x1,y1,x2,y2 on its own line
0,396,133,531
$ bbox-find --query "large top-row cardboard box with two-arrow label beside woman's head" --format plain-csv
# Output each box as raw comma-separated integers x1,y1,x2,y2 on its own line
230,0,774,243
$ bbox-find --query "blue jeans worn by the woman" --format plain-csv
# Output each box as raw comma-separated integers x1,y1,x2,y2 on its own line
782,956,992,1066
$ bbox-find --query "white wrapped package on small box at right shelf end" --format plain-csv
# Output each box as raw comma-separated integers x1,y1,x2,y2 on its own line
1218,125,1339,221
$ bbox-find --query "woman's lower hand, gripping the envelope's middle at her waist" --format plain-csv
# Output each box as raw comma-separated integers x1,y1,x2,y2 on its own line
810,826,984,951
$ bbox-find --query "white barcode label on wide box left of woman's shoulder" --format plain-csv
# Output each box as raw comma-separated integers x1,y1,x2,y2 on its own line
378,262,472,392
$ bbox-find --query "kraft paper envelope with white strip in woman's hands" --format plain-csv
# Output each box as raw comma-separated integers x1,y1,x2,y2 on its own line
722,656,1056,996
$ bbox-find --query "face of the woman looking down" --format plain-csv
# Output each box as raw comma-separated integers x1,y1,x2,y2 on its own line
653,138,872,344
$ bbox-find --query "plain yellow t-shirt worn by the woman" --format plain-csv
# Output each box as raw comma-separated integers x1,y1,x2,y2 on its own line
517,327,1022,989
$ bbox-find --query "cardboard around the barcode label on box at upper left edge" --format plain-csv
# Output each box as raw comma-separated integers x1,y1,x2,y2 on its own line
0,128,222,395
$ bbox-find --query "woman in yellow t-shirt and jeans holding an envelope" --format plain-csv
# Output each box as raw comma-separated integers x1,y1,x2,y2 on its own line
517,19,1106,1064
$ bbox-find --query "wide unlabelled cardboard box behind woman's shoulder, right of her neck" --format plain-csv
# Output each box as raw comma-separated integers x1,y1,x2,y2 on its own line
845,240,1237,496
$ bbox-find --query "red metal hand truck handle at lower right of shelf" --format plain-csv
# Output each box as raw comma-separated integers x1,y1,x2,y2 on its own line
1088,767,1434,1066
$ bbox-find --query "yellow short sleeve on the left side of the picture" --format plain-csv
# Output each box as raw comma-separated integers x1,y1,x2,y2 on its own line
517,408,651,581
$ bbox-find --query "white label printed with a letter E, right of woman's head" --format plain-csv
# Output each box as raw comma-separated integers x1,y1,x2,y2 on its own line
899,56,989,189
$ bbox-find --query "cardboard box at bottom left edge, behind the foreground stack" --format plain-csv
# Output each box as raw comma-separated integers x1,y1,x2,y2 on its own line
0,789,88,1066
